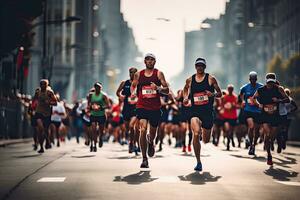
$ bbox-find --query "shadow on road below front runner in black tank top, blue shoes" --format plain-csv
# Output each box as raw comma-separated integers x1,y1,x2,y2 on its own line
178,172,221,185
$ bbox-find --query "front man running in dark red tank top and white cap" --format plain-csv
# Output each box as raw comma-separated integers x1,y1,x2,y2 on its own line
131,53,169,168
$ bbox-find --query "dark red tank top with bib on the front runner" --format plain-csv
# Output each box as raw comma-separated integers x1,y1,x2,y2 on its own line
136,69,161,110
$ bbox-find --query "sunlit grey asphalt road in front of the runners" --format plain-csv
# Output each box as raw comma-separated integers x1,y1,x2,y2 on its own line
0,140,300,200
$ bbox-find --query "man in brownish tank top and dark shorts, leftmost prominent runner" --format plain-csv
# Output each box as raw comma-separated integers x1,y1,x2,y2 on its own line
33,79,57,153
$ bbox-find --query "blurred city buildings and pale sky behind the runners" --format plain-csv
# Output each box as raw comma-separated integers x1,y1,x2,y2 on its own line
0,0,300,140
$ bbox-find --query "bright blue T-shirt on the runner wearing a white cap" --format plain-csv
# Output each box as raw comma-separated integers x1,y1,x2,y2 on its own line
241,83,263,113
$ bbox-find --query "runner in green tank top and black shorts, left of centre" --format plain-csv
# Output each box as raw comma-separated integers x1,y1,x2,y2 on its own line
88,82,110,152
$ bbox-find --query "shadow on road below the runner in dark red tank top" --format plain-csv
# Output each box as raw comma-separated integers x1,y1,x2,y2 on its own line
114,171,158,185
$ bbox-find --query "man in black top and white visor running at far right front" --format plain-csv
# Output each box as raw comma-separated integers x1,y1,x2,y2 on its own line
253,73,290,165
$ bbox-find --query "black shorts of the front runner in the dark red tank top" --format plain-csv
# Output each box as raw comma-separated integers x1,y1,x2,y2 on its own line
136,108,162,127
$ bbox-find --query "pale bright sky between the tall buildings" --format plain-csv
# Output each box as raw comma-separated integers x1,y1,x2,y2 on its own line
121,0,226,80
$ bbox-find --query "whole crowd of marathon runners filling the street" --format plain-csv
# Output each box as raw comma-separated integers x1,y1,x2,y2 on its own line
29,53,297,171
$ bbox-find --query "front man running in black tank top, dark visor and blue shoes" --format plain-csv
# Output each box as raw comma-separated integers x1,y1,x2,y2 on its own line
183,58,222,171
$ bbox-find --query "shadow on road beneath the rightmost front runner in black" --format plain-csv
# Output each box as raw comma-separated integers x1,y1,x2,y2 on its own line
264,167,299,181
